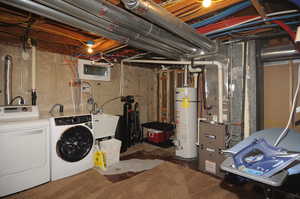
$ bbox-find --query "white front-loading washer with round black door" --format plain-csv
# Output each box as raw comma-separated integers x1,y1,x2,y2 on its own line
50,115,94,181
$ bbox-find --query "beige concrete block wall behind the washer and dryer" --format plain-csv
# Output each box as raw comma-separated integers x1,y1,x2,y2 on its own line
0,44,157,122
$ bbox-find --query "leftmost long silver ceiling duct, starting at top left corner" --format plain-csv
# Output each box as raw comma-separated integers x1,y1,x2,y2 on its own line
0,0,174,58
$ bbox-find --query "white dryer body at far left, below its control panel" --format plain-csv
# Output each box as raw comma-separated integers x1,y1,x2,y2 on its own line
0,118,50,198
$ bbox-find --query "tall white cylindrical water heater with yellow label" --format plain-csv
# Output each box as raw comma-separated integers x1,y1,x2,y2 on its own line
175,88,197,158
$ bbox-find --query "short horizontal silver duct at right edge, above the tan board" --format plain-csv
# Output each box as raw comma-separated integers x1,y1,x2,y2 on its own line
260,45,300,61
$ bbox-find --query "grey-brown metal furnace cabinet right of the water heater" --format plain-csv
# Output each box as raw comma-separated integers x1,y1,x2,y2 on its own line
198,121,227,178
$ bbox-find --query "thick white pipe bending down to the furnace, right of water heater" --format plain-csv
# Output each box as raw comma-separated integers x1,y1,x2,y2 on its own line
189,61,223,123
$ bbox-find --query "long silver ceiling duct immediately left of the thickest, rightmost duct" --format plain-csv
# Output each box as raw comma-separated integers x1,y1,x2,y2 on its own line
64,0,199,54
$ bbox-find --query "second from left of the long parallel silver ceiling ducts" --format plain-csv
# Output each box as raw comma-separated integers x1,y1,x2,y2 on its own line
36,0,183,57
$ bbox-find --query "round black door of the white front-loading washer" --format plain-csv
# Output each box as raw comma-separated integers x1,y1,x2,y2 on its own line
56,126,93,162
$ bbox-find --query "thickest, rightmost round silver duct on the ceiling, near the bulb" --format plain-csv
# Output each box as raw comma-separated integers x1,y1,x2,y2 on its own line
122,0,216,52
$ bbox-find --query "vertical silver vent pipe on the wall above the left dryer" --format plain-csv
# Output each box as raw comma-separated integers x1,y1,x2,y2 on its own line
4,55,12,106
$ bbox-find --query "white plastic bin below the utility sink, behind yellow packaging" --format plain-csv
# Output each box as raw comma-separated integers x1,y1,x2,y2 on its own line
100,138,122,167
